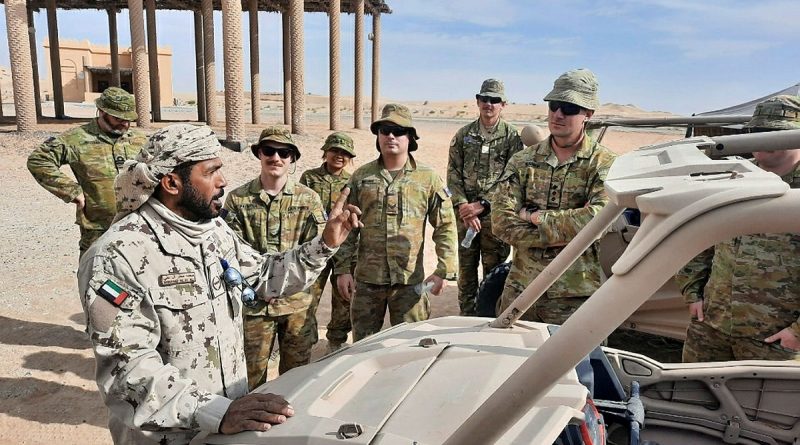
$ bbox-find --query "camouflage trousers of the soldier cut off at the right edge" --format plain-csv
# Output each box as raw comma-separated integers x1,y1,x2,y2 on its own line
683,320,797,363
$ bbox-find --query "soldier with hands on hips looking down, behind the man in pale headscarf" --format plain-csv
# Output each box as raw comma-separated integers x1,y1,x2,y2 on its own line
28,87,147,254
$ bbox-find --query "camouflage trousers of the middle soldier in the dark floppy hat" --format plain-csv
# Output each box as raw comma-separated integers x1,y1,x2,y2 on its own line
350,281,431,341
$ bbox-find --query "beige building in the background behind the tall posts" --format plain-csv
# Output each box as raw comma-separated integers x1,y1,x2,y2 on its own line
42,40,172,106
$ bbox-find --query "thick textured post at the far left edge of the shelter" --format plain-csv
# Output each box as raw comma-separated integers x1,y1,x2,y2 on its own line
6,0,36,133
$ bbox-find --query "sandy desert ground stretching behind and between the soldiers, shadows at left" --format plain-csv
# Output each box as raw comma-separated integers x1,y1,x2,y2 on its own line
0,101,681,444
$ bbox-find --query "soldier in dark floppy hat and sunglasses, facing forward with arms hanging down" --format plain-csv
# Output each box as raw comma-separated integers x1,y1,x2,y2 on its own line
334,104,457,341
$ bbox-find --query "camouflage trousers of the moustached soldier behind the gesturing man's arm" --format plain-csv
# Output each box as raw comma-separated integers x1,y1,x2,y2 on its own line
244,310,317,390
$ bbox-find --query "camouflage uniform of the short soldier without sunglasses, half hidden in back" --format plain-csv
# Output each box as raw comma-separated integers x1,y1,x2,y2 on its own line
300,164,350,345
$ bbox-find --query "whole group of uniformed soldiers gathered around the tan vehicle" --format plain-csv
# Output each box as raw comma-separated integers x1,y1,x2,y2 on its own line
28,69,800,443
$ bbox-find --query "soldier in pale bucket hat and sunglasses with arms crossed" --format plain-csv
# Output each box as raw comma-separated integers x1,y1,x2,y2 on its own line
491,69,615,324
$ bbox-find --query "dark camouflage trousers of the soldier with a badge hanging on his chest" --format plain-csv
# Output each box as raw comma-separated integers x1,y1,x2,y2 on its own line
458,217,511,315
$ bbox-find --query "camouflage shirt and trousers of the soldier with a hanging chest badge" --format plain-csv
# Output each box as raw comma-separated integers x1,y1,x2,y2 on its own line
447,119,523,315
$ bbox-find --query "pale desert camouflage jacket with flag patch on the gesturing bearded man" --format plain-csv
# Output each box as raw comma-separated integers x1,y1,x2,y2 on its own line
78,199,335,445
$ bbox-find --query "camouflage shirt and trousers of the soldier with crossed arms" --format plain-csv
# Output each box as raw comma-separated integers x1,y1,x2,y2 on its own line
491,135,615,323
